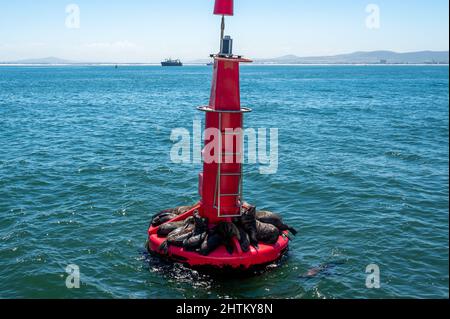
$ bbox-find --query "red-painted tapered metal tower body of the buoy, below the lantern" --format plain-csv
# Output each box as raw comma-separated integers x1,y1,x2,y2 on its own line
200,58,243,223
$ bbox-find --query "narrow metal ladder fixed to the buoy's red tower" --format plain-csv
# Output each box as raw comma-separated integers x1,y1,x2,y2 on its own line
214,111,244,218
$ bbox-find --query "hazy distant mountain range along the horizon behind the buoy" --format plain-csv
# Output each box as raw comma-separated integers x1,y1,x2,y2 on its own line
0,51,449,65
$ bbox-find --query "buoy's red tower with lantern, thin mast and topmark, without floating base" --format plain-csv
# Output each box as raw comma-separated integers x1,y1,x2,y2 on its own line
199,0,251,224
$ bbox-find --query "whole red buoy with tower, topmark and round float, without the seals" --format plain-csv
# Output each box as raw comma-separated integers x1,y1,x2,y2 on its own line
148,0,289,268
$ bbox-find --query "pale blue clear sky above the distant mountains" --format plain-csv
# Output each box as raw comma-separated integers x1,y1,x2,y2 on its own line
0,0,449,63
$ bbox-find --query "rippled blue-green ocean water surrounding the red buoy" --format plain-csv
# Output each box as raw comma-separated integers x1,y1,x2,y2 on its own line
0,66,449,298
